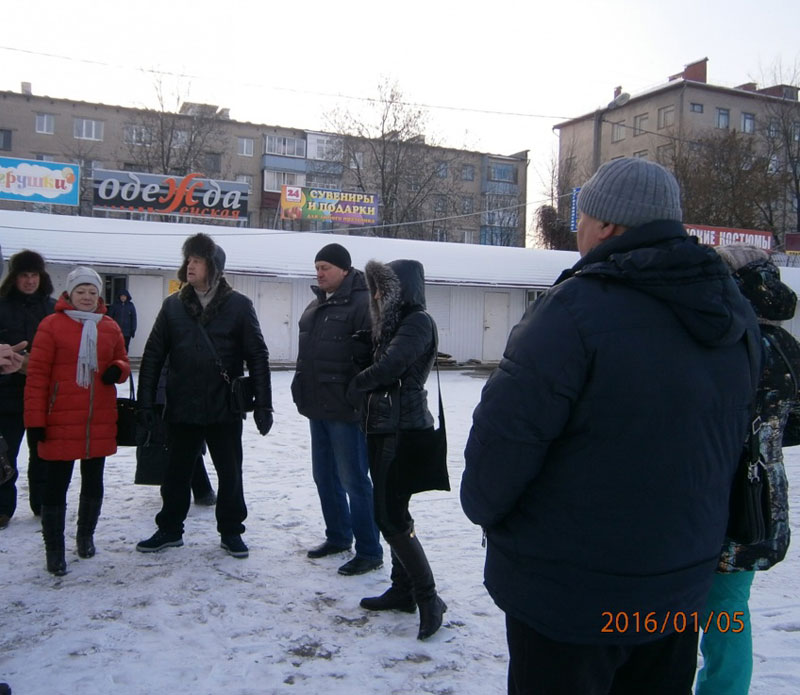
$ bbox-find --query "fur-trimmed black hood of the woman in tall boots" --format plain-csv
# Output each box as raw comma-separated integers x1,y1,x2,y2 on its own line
364,260,425,347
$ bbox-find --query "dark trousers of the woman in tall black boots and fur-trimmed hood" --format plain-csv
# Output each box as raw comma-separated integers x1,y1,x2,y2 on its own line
367,434,414,538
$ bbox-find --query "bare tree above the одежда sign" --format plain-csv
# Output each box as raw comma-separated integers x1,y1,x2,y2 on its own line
120,80,228,177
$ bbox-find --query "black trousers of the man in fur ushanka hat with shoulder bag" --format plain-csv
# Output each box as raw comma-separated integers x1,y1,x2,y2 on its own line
156,420,247,535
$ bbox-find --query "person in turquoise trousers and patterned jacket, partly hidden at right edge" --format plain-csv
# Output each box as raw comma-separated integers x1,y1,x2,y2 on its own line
695,246,800,695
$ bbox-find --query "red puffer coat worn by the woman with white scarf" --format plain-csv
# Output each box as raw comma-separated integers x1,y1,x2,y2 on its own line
25,293,131,461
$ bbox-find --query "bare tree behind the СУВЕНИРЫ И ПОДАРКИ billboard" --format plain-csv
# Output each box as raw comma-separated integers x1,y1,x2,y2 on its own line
328,82,457,239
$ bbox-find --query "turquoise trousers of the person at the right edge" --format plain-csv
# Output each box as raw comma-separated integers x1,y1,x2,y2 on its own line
695,572,756,695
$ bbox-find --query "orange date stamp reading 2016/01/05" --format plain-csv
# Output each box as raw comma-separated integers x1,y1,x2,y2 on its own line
600,611,744,635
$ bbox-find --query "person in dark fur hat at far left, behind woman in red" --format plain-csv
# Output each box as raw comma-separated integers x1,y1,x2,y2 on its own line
0,249,56,528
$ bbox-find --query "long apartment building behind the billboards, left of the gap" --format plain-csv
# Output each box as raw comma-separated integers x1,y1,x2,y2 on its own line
0,83,528,246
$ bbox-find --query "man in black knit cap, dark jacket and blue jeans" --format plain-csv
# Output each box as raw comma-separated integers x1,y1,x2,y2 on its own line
292,244,383,575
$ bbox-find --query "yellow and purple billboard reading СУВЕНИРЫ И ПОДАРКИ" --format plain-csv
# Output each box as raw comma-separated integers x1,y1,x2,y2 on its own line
281,186,378,226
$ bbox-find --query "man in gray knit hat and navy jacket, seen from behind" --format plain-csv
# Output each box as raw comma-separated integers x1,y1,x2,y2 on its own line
461,159,760,695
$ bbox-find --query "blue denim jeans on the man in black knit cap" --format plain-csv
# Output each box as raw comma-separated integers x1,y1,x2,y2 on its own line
309,420,383,558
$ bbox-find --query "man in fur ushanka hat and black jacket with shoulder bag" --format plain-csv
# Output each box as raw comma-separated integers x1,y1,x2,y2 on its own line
136,234,272,558
